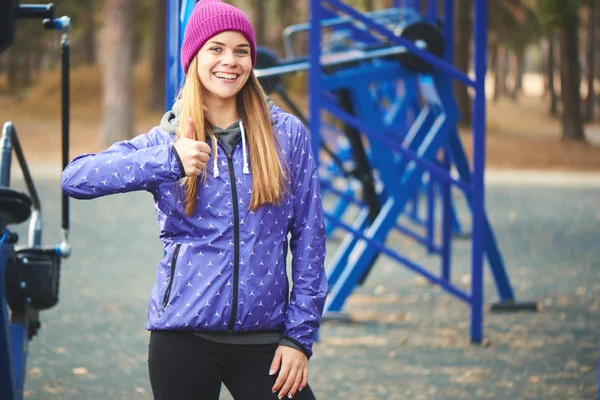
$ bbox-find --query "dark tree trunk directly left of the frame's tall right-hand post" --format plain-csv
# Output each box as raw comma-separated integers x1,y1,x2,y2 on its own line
454,0,473,126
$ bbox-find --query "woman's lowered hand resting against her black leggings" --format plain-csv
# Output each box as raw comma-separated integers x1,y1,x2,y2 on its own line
269,346,308,399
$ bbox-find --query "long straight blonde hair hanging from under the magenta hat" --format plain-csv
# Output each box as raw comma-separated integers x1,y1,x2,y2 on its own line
175,57,287,216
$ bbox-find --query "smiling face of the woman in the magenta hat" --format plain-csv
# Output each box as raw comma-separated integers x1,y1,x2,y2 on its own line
197,31,252,100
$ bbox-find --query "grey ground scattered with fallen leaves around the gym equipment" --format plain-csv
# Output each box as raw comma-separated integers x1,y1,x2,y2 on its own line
3,175,600,400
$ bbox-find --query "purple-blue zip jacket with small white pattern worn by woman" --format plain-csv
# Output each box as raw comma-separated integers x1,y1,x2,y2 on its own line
62,106,327,357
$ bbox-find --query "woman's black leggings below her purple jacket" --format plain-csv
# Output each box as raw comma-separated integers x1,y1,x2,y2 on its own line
148,331,315,400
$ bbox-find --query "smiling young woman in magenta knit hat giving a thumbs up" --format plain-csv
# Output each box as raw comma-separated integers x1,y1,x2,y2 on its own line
62,0,327,400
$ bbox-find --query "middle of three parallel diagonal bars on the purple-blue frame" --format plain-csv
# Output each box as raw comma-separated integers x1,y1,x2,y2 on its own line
323,95,471,193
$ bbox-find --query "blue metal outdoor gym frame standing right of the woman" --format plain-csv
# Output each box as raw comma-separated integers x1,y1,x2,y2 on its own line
302,0,535,342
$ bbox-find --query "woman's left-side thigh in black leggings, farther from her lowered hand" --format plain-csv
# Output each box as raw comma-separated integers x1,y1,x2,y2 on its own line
148,331,223,400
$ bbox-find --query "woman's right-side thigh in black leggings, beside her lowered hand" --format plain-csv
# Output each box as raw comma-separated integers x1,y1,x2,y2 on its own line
223,344,315,400
